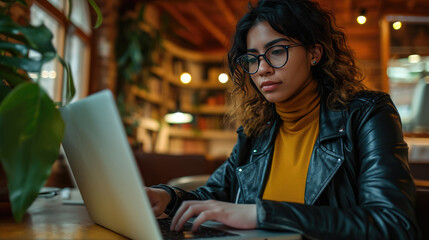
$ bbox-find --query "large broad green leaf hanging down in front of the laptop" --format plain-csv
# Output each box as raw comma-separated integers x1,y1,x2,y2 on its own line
0,83,64,222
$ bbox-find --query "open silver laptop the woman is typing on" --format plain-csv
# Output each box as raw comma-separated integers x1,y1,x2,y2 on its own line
60,90,301,240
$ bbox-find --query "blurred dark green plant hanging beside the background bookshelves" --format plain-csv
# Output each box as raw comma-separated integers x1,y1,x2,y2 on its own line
115,4,161,139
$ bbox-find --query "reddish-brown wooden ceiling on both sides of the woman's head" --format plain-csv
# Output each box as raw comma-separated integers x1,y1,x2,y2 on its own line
136,0,429,53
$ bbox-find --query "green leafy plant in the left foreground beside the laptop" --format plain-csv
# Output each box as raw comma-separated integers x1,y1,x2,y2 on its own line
0,0,101,222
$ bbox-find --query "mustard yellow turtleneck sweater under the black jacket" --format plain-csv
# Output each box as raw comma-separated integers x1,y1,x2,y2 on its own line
263,80,320,203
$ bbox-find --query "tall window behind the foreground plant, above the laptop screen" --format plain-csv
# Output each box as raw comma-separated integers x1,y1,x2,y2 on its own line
30,0,91,102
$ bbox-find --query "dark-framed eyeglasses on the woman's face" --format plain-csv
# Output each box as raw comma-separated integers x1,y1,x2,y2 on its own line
237,44,302,74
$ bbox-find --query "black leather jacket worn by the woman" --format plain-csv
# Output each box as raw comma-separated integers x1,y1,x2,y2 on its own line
157,92,419,239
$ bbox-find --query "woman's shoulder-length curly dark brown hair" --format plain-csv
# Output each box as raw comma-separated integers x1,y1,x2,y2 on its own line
227,0,366,136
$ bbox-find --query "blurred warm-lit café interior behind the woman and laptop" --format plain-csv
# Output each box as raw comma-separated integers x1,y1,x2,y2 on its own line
14,0,429,184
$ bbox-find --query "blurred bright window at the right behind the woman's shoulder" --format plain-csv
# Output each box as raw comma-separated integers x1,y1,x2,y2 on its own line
386,16,429,133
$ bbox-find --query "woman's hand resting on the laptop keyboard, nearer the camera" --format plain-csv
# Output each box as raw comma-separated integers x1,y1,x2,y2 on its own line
170,200,257,231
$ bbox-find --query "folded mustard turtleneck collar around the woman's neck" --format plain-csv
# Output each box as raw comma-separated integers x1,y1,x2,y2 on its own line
275,80,320,131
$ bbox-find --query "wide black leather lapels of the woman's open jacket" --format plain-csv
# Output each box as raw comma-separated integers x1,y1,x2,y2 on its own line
238,91,346,205
